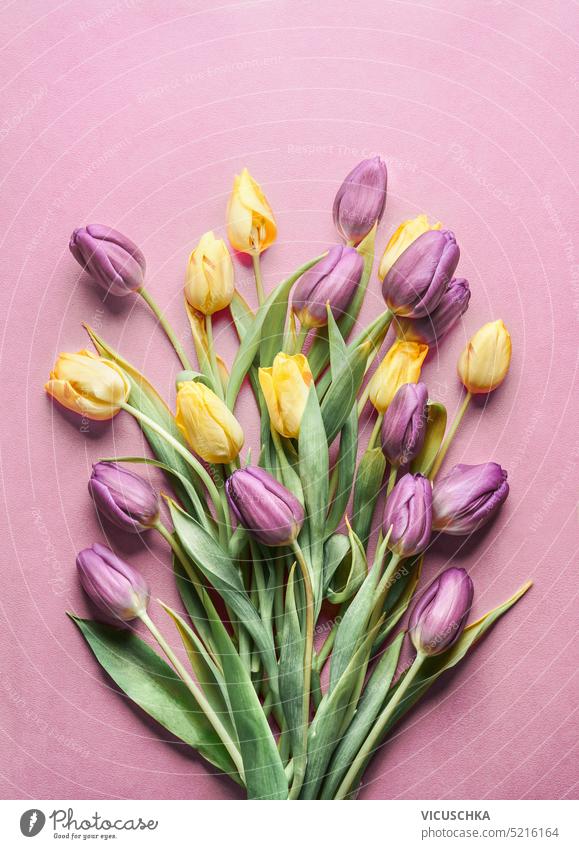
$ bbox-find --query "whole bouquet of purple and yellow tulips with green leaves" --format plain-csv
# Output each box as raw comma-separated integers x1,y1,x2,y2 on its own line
46,157,530,799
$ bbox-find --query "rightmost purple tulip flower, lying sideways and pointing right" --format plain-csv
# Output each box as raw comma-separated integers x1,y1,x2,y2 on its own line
432,463,509,536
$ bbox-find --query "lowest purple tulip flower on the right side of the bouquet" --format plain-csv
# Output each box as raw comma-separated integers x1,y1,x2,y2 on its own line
408,567,474,655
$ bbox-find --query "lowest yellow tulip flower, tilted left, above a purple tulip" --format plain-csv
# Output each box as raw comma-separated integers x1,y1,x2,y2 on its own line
175,380,244,463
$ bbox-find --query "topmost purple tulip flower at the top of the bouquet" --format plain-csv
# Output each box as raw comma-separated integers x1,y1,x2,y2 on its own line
333,156,388,245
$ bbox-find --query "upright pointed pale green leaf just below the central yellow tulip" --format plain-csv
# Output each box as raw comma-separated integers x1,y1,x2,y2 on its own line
299,384,329,613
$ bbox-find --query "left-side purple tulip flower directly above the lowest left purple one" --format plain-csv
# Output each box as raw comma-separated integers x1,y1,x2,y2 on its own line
88,463,159,534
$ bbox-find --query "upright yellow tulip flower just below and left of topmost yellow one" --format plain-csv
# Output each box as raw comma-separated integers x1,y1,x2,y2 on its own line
185,230,234,315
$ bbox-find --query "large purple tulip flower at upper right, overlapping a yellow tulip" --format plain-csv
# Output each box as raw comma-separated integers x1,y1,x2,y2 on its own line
382,230,460,318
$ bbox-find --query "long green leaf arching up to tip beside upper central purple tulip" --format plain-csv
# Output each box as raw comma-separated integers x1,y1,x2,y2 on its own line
225,256,322,410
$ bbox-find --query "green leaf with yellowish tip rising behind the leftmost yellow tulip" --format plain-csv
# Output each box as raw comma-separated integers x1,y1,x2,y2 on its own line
85,325,203,511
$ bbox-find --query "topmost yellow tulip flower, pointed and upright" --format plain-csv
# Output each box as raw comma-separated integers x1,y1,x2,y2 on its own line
227,168,277,255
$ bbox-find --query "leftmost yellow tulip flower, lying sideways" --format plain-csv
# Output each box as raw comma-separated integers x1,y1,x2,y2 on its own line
44,351,130,421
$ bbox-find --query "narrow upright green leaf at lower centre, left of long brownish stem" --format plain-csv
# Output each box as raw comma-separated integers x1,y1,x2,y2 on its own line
279,564,305,757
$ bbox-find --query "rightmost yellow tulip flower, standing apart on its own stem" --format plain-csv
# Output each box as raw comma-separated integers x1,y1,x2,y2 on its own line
458,319,512,395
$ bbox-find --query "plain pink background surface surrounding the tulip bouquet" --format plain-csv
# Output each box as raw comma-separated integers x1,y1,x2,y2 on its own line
0,0,579,799
